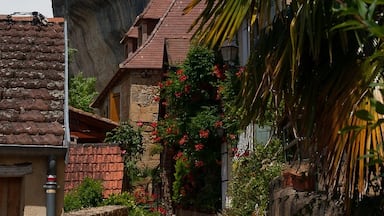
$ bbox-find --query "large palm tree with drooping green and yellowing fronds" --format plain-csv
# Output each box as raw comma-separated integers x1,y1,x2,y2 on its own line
185,0,384,213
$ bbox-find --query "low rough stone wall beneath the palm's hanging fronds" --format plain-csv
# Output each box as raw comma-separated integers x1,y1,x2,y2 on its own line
268,163,345,216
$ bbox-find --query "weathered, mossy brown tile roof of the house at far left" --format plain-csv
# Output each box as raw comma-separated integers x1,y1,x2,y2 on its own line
0,15,64,145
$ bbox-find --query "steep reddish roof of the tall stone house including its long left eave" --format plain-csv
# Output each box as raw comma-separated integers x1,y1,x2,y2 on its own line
91,0,205,107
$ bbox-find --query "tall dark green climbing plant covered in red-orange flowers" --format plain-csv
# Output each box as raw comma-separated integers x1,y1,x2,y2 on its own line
154,47,240,212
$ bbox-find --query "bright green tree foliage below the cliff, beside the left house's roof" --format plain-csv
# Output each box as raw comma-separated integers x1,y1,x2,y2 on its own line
69,73,98,112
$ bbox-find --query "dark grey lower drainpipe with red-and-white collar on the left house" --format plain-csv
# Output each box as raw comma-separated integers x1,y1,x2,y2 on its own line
44,155,57,216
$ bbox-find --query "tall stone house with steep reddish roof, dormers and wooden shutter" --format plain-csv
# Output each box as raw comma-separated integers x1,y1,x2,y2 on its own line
91,0,202,167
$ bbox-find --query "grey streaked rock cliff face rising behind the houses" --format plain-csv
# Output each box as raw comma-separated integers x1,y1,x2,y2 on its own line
52,0,149,92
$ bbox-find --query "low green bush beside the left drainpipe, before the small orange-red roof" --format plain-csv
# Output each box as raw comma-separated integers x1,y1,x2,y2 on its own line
64,177,103,211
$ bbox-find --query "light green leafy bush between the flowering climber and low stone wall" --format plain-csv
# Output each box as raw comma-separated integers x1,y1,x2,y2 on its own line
226,140,283,216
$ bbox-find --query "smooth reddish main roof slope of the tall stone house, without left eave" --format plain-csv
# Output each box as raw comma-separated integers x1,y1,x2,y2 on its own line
120,0,205,69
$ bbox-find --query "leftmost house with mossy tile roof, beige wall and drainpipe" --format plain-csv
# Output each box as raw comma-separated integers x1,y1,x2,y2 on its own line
0,12,69,216
